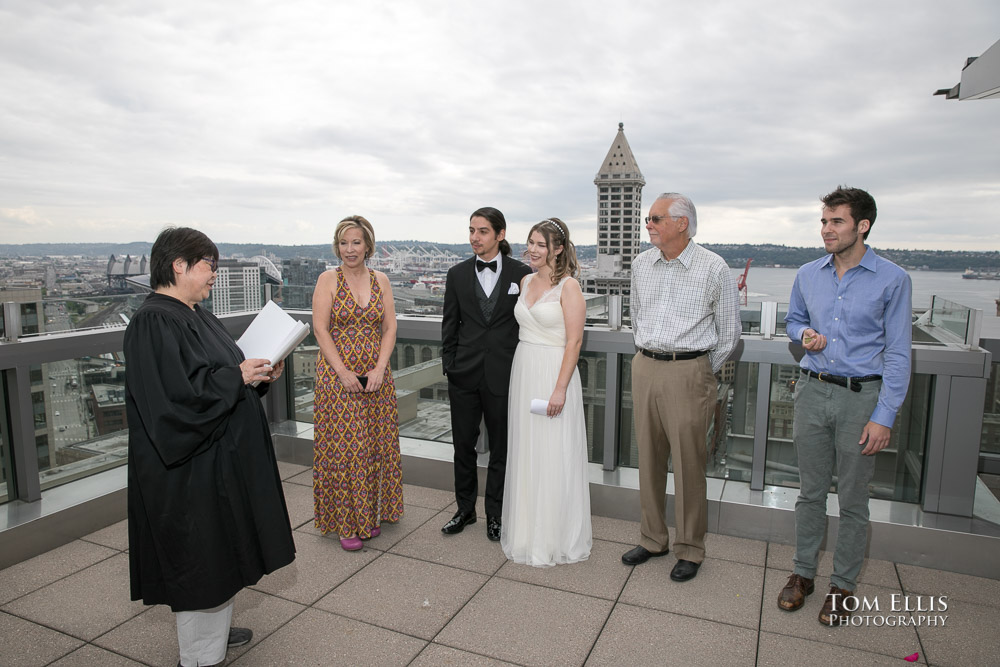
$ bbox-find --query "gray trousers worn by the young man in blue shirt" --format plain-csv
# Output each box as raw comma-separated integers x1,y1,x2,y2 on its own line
792,375,882,591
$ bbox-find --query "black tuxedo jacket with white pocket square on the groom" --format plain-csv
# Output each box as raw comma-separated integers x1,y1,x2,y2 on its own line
441,256,531,396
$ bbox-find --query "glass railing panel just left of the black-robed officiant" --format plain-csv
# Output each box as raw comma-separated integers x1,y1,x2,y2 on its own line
31,352,128,490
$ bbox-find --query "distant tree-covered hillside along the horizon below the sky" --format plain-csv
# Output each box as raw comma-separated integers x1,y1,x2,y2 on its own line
0,241,1000,271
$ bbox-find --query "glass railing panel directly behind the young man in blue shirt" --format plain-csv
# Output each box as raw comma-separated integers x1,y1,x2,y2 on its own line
764,365,933,503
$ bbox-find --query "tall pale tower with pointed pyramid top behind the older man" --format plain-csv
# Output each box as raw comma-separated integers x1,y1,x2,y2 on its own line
594,123,646,276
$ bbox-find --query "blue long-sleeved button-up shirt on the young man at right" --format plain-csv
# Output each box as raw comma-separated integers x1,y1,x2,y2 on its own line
785,246,913,428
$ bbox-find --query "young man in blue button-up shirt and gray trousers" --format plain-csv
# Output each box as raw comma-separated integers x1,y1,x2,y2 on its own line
778,187,912,625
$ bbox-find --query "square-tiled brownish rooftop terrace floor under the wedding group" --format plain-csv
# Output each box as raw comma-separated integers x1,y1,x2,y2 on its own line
0,463,1000,667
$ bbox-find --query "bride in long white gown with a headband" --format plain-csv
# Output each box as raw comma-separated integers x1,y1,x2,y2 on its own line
500,218,593,567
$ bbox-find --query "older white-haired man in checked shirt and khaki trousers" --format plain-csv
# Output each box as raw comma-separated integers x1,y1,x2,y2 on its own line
622,192,740,581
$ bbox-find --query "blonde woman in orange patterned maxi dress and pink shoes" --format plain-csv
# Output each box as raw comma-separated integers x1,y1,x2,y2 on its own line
313,215,403,551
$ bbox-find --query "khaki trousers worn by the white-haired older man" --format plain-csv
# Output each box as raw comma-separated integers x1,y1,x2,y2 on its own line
632,353,716,563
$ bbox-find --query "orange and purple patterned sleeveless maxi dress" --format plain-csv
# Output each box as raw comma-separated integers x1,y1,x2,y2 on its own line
313,268,403,538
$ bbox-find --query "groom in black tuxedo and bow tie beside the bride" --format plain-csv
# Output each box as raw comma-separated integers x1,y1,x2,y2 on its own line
441,206,531,542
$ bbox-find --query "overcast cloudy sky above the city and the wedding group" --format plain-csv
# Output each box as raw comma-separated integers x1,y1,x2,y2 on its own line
0,0,1000,250
